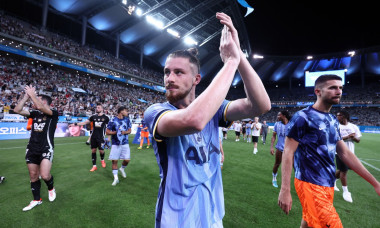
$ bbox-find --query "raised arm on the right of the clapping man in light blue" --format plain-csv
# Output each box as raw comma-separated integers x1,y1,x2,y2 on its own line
216,13,271,120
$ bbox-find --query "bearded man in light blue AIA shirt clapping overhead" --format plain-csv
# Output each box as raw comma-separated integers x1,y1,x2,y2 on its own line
144,13,270,228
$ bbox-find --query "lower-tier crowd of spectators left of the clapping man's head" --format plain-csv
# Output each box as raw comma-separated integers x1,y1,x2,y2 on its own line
0,54,165,122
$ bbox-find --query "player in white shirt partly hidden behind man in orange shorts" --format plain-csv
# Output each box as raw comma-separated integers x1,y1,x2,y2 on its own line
334,110,362,203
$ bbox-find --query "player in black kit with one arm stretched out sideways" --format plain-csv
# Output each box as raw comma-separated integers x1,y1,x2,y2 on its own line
73,104,110,172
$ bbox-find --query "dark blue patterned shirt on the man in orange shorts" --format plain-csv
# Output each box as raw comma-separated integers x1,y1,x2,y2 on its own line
287,106,342,187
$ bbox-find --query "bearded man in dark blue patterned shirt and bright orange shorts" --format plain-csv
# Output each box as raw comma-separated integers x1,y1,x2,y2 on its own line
278,75,380,228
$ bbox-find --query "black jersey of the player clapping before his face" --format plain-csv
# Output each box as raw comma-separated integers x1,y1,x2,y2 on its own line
27,110,58,151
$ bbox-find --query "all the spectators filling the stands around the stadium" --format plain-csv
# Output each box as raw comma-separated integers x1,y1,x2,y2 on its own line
0,12,380,126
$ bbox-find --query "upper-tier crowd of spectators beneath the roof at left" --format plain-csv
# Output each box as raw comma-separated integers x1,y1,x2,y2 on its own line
0,12,163,85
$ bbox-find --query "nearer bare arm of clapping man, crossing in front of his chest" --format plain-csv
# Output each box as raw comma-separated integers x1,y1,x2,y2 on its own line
156,26,240,137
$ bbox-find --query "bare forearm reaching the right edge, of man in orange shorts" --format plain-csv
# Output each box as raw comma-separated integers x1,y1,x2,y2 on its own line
336,140,380,196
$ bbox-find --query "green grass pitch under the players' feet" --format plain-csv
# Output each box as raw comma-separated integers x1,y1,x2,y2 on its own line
0,131,380,228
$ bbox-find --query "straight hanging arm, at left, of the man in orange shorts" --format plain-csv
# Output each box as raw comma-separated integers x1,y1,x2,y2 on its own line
278,137,298,214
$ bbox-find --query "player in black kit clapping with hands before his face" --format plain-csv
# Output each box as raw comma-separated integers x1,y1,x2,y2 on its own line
14,86,58,211
